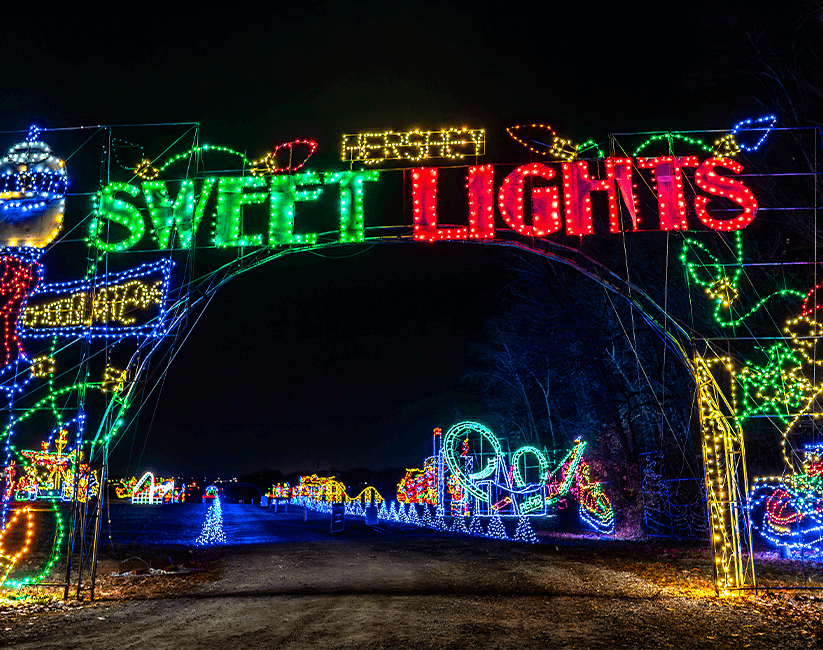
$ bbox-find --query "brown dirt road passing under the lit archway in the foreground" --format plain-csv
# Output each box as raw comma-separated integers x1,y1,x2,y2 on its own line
0,506,818,650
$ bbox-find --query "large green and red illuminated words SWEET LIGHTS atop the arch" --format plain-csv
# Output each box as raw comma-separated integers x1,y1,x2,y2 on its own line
89,156,758,252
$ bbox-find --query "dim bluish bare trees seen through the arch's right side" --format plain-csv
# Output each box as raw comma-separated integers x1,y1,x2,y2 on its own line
464,248,699,531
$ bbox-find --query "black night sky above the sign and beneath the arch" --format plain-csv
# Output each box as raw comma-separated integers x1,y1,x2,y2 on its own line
0,2,772,475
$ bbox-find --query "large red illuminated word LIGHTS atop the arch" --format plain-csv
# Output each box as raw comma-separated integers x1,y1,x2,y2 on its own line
411,156,757,241
